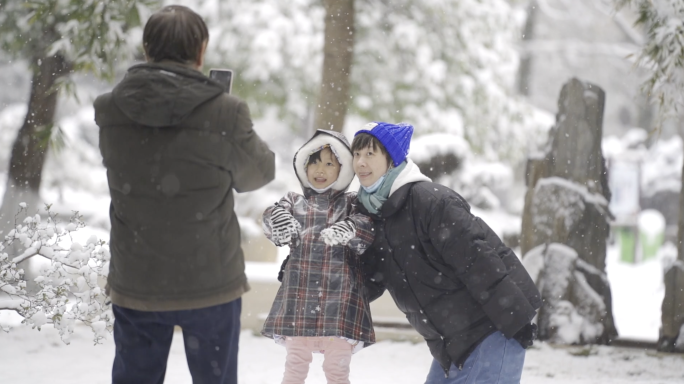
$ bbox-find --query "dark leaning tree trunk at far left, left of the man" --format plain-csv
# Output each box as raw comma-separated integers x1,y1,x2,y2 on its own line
0,55,70,226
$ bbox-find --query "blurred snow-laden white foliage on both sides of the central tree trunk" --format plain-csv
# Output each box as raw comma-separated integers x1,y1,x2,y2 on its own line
197,0,547,160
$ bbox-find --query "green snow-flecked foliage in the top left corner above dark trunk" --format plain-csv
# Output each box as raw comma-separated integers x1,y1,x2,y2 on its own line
0,0,160,79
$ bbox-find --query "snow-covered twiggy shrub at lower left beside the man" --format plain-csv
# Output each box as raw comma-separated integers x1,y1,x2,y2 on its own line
0,203,109,344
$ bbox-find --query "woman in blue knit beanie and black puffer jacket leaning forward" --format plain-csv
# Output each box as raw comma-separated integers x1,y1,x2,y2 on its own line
352,122,541,384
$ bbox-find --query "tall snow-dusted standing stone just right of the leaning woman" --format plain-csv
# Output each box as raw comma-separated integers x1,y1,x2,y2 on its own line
521,78,617,343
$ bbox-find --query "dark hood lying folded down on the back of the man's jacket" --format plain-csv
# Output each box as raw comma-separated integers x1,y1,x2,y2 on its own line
112,63,223,127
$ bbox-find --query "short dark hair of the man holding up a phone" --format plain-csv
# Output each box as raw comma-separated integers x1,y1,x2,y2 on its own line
143,5,209,64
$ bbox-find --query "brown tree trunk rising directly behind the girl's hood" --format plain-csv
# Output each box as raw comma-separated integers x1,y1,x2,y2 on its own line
314,0,354,132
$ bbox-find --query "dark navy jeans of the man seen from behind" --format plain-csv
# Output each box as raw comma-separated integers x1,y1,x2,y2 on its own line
112,299,242,384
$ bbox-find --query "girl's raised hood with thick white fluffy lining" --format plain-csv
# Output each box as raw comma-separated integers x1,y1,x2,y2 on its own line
292,129,354,191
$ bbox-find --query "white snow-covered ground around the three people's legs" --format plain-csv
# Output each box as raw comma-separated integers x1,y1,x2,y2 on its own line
0,316,684,384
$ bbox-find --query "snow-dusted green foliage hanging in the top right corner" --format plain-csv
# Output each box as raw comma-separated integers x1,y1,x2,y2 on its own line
615,0,684,121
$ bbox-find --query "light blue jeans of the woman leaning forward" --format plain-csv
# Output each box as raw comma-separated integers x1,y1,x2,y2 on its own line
425,332,525,384
